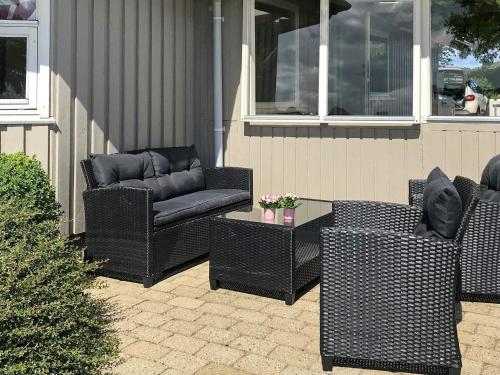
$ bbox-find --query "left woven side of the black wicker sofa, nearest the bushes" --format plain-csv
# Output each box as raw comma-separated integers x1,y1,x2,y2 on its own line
83,187,154,276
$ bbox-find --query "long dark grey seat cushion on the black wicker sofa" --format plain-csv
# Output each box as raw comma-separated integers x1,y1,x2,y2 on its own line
153,189,250,227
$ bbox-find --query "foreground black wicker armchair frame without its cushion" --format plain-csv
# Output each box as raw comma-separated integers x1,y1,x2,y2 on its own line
320,178,477,374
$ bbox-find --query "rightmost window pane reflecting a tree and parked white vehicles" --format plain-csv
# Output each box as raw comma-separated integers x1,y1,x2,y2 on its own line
431,0,500,118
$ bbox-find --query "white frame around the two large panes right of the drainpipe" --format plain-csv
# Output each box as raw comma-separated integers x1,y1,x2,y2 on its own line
241,0,420,126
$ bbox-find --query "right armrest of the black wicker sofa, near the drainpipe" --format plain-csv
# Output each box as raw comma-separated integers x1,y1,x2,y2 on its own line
204,167,253,195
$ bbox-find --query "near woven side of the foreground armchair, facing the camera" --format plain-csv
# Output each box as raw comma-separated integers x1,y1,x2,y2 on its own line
320,228,460,366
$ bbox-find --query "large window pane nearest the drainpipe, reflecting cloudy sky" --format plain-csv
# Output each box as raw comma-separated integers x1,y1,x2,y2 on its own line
255,0,319,116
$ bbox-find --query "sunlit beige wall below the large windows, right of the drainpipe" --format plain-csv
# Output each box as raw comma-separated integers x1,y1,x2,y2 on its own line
219,0,500,203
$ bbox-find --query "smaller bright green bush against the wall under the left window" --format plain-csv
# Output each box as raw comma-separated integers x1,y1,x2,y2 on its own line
0,153,60,222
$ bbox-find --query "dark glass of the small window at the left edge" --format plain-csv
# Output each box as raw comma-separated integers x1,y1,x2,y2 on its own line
0,37,27,99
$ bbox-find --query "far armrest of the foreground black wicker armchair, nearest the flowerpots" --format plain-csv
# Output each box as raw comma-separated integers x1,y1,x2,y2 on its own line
332,201,422,233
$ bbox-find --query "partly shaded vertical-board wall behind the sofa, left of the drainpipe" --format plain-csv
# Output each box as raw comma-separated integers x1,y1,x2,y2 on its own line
48,0,212,233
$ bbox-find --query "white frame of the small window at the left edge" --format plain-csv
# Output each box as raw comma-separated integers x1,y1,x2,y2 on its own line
0,0,54,124
